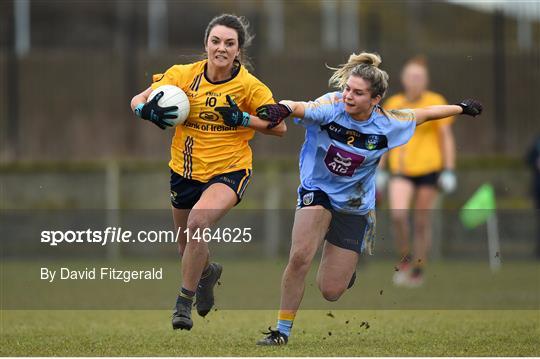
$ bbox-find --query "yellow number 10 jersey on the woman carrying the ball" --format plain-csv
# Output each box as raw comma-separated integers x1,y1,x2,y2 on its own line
152,60,275,182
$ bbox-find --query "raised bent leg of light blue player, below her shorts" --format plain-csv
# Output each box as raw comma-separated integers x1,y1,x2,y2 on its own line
317,241,359,302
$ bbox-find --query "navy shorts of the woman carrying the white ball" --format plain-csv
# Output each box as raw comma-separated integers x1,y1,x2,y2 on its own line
171,169,251,209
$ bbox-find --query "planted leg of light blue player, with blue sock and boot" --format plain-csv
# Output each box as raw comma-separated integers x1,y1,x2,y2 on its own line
257,206,332,345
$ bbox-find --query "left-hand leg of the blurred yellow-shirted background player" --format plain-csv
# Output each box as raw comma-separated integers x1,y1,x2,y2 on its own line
388,177,414,285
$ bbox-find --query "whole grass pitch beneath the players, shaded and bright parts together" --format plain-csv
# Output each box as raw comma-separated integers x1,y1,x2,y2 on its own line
0,261,540,356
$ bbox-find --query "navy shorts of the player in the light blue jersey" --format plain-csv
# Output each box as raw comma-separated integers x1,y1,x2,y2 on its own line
297,186,375,254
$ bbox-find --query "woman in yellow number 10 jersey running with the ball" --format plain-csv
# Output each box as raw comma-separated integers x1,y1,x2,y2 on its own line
131,14,286,330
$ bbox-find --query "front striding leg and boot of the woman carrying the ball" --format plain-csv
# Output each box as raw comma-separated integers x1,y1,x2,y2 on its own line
173,183,237,330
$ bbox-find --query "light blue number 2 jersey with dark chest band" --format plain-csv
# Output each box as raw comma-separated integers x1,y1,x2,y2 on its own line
296,92,416,215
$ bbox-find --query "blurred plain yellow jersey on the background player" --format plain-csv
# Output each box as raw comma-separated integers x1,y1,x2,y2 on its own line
384,91,454,177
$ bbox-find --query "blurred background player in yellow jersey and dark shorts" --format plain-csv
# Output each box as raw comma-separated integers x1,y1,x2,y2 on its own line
377,57,457,287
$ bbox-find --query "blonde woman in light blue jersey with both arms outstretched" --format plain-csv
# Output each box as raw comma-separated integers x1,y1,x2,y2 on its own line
257,53,482,345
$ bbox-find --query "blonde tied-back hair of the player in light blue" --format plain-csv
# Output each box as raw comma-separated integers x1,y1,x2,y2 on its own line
327,52,388,97
